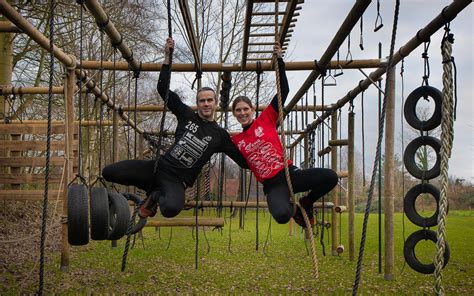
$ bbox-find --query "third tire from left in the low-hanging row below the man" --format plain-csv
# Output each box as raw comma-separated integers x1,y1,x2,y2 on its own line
107,192,130,240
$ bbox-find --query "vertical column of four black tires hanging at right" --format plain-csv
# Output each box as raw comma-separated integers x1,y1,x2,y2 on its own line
403,85,450,274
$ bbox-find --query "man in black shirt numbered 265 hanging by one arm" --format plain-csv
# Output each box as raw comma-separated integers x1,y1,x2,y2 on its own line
102,38,248,218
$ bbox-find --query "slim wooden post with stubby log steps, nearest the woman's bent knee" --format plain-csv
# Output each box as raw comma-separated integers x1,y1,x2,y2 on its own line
331,111,340,256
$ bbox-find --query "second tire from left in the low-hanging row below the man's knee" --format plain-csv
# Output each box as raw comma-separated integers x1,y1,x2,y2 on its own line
90,187,109,240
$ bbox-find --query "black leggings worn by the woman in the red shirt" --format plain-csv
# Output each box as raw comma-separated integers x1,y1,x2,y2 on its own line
263,167,338,224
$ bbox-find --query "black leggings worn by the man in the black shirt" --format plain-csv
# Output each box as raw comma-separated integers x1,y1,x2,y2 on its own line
102,160,186,218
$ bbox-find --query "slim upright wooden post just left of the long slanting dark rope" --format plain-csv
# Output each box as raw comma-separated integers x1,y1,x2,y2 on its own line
347,112,355,261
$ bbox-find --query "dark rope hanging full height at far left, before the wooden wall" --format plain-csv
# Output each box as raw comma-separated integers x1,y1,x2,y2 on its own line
38,0,56,295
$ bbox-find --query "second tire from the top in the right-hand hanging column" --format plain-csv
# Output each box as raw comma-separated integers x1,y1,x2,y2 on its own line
403,136,441,180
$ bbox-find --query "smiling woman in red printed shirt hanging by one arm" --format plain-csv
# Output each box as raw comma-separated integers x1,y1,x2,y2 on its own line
232,42,338,227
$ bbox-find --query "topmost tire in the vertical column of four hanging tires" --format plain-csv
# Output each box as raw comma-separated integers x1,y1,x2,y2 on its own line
403,86,443,131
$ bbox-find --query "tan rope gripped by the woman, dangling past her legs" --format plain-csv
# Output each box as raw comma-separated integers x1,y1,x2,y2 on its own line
273,0,319,278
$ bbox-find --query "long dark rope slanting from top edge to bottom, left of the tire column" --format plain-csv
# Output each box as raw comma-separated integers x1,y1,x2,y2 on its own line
352,0,400,295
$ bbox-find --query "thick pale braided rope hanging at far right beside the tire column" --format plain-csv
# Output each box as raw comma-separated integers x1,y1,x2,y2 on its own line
434,24,454,295
